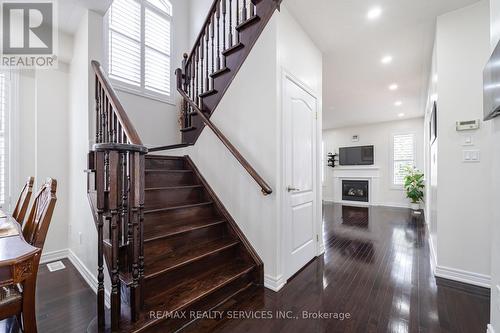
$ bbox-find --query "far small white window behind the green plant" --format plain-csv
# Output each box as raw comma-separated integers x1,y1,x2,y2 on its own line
392,133,415,187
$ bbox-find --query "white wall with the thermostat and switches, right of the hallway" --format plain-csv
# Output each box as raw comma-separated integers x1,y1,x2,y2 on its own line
430,1,491,286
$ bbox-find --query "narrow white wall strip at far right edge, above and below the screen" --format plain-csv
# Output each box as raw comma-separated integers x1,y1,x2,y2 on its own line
489,0,500,333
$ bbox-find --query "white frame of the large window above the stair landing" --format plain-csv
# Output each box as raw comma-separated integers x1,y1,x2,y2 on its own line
104,0,175,105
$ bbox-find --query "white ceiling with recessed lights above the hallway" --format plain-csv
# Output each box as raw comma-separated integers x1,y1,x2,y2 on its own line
286,0,478,129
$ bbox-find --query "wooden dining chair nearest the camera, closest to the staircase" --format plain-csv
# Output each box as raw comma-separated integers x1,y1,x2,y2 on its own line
0,178,57,333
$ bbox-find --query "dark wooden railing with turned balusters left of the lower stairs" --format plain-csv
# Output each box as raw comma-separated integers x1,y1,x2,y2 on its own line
91,61,147,331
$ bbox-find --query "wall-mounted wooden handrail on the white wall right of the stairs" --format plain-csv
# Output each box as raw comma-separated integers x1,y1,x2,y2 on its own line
176,69,273,195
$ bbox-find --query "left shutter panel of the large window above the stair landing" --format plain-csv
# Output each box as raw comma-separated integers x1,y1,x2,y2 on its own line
108,0,141,87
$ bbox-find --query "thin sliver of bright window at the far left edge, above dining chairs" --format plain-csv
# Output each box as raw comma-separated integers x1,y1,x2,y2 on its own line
0,72,10,208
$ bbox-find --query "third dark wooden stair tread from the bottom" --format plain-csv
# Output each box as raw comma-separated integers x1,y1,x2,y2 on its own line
144,216,225,242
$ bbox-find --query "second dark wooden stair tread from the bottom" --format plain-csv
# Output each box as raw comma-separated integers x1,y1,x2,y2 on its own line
145,237,240,279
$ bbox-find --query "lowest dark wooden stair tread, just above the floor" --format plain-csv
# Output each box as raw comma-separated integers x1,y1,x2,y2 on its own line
146,260,255,311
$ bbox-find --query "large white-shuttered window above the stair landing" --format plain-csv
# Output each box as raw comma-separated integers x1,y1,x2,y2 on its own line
107,0,172,101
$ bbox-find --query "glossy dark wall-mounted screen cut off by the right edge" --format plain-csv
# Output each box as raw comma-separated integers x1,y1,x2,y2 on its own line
483,39,500,120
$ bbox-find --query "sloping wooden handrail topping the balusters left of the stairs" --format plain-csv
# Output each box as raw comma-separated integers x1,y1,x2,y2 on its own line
92,60,142,146
